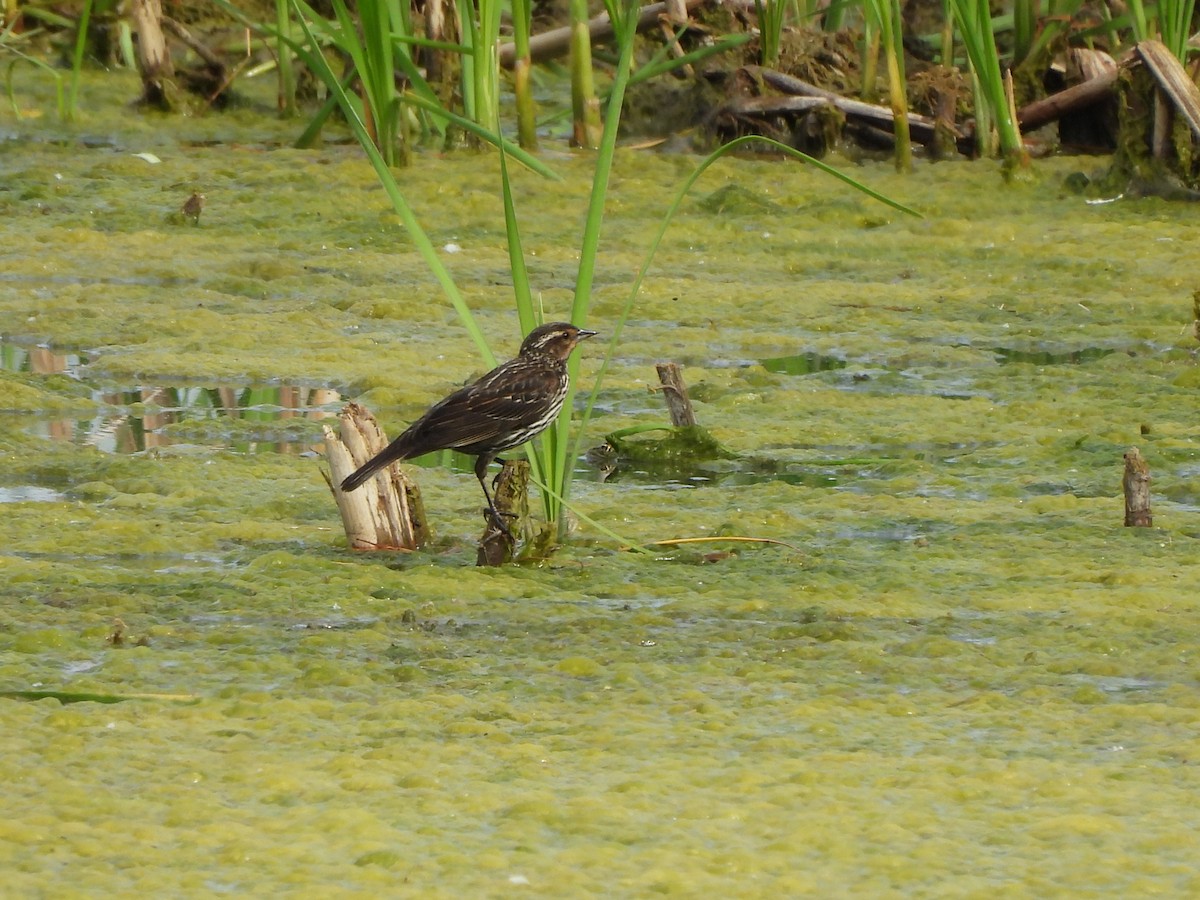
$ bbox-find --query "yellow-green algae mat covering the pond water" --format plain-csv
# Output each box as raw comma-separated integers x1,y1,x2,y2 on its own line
0,75,1200,898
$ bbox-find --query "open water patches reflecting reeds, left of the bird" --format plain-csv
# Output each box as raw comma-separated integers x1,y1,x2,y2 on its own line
0,342,342,454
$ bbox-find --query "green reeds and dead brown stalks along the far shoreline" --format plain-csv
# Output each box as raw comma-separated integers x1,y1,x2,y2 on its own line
7,0,1200,183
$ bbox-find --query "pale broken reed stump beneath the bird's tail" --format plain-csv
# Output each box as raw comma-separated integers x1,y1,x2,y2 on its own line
325,403,430,551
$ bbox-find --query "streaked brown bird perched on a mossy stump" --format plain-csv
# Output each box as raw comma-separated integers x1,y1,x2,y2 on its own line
342,322,595,522
